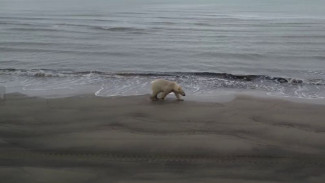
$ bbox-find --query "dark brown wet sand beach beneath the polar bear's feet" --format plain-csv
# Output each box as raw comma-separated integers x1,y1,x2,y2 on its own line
0,94,325,183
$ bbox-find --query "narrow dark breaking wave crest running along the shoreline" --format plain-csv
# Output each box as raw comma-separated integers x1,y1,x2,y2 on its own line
0,68,325,85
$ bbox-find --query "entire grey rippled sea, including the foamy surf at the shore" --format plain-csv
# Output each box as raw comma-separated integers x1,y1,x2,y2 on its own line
0,0,325,98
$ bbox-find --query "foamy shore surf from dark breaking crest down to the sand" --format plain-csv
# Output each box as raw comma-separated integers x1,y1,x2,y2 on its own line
0,68,325,99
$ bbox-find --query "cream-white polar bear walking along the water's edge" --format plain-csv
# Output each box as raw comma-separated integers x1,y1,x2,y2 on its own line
151,79,185,100
